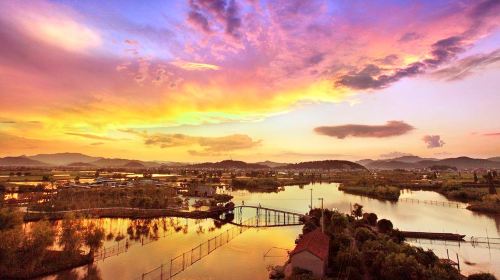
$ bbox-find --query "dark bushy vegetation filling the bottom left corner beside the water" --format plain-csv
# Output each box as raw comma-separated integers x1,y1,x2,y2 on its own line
0,208,104,278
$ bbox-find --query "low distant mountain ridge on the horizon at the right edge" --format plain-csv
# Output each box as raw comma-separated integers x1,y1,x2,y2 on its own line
363,156,500,169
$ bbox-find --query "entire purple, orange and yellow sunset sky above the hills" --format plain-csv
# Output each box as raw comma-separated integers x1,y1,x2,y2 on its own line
0,0,500,162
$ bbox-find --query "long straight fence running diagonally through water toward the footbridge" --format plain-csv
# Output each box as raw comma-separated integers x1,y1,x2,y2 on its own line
137,218,256,280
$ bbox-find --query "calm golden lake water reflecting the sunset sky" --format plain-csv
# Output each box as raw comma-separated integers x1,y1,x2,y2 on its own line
44,183,500,280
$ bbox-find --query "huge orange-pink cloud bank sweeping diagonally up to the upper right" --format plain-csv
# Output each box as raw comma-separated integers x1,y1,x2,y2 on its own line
0,0,500,150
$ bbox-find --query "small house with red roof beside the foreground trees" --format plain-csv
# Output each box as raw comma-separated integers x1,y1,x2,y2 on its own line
285,228,330,279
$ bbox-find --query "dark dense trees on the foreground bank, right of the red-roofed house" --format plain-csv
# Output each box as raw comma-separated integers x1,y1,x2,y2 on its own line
293,205,488,280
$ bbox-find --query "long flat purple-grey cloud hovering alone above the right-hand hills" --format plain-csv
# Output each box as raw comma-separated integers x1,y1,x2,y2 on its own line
314,121,414,139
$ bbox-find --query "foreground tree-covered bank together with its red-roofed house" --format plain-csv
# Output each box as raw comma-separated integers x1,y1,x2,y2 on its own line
278,209,496,280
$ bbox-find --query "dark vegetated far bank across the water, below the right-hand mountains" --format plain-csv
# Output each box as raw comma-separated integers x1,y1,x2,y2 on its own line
333,169,500,213
